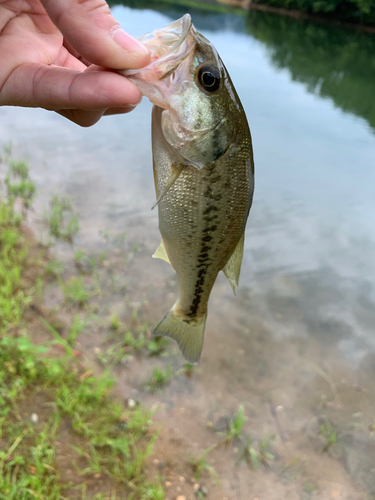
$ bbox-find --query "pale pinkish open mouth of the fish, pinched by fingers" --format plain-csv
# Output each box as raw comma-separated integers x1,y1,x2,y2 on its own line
120,14,196,109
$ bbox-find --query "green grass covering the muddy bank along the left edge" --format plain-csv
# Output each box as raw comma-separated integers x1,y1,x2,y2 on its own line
0,150,164,500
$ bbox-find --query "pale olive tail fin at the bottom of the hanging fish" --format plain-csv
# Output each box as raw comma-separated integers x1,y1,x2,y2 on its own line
153,309,207,363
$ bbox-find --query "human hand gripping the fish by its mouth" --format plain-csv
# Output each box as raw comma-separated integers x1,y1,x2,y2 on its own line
0,0,150,127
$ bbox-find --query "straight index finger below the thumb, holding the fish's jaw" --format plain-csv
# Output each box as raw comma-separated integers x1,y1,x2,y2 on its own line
0,63,142,111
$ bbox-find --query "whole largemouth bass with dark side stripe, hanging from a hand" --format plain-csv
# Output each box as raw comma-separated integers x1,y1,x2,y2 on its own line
122,14,254,364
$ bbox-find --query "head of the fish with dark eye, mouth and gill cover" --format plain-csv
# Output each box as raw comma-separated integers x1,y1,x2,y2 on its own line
122,14,240,168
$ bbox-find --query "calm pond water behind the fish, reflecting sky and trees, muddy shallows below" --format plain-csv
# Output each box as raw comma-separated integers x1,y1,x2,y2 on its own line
0,5,375,500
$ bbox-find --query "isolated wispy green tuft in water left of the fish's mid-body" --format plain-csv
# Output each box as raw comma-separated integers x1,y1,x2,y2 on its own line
47,194,79,243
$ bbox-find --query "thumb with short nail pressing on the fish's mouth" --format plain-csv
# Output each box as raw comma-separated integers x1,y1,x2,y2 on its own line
41,0,150,69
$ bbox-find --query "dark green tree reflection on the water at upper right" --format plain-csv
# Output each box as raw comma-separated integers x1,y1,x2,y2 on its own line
246,11,375,132
